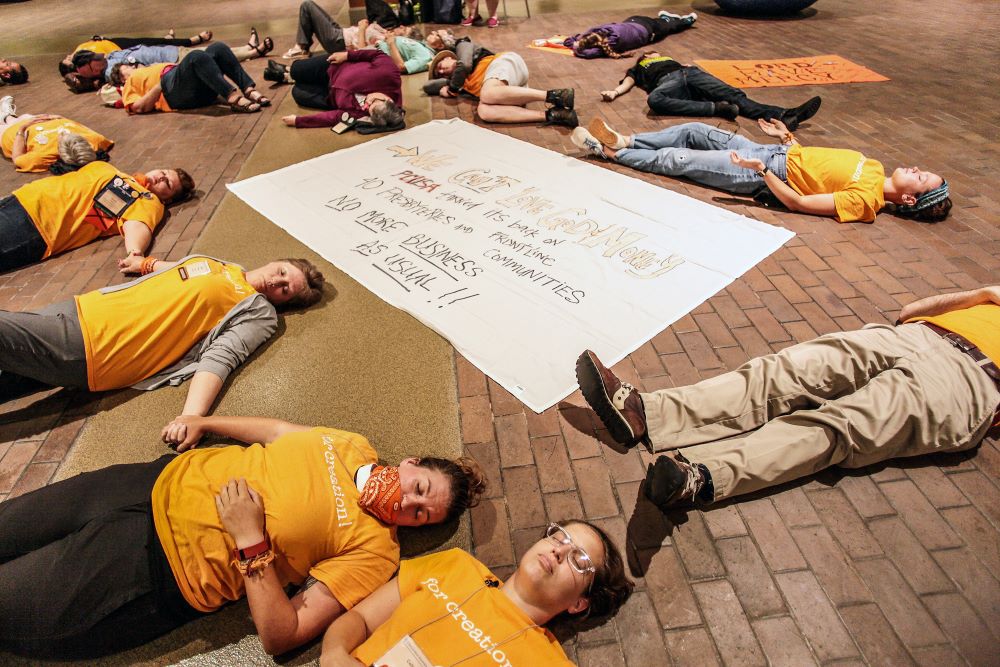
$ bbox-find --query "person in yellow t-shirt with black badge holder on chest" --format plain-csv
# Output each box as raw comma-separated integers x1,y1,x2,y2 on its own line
0,160,194,271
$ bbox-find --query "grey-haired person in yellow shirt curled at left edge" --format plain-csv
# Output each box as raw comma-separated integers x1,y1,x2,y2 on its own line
0,95,115,173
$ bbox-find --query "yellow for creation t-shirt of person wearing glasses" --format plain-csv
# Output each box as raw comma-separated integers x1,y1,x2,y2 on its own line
353,549,573,667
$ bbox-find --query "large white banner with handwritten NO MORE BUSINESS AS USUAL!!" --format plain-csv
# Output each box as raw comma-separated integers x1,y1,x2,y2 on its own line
229,119,793,412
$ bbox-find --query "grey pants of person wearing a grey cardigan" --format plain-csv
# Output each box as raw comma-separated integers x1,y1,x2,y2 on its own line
0,300,88,389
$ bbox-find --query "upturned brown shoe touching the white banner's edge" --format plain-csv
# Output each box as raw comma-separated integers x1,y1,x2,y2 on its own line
576,350,647,447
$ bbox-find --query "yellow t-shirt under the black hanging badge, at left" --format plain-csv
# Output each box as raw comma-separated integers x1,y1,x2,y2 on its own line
12,161,163,259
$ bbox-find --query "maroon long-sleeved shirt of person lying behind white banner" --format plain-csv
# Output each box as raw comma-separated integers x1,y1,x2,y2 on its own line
295,49,403,127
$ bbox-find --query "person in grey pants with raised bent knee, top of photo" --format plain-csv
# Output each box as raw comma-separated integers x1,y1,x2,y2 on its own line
281,0,415,59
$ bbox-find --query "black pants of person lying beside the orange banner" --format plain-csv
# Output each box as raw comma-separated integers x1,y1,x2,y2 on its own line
646,65,787,119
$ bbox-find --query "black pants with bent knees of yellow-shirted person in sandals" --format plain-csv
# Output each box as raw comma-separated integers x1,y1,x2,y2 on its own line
160,42,254,109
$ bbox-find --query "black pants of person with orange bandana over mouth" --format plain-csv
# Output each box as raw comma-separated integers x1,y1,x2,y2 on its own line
0,454,202,657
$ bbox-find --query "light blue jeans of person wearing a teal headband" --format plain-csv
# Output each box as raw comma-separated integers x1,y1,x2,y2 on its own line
615,123,788,195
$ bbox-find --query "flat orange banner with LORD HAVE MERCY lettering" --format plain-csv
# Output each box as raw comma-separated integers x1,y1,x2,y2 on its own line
695,55,889,88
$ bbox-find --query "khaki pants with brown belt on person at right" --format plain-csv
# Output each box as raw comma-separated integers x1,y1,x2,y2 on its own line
642,324,1000,500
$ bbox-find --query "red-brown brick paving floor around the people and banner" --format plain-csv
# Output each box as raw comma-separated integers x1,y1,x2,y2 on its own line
0,0,1000,667
